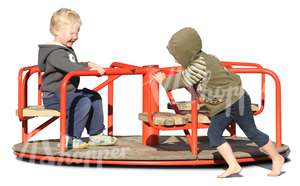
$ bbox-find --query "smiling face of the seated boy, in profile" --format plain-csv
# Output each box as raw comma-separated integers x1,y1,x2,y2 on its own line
55,24,80,47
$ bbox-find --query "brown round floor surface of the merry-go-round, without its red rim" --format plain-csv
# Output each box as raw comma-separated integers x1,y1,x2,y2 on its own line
13,136,289,161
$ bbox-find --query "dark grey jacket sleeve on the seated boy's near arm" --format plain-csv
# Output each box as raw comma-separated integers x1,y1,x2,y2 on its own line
47,50,89,72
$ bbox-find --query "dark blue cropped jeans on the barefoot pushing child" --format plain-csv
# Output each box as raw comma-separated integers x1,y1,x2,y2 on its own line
207,91,269,147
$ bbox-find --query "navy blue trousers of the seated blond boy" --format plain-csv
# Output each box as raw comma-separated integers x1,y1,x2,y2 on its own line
43,88,105,138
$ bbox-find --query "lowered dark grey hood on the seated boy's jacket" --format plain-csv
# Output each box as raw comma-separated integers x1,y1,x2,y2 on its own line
38,44,68,72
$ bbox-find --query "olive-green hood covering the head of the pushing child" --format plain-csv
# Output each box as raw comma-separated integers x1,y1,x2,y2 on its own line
167,27,202,67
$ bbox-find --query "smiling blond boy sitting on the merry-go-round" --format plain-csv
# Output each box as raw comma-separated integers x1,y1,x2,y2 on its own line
38,8,117,148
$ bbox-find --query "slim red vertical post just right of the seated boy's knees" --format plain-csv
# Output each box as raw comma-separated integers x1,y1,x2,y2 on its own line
107,77,114,136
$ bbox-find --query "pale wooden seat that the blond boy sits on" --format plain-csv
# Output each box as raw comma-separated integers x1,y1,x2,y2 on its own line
17,105,60,117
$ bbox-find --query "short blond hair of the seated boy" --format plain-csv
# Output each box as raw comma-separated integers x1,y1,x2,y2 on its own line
50,8,81,36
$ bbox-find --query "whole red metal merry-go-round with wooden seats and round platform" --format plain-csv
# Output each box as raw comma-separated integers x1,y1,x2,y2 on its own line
13,62,290,166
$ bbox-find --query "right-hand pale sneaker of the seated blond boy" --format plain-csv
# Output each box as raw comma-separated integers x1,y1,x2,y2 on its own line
88,133,118,146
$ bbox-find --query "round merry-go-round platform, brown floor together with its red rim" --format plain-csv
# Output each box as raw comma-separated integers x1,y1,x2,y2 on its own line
13,136,290,166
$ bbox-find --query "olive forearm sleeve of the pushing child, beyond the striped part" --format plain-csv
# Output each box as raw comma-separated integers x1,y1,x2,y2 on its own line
162,72,185,91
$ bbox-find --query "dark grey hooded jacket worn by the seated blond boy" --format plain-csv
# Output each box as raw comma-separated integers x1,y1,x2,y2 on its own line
38,44,88,98
